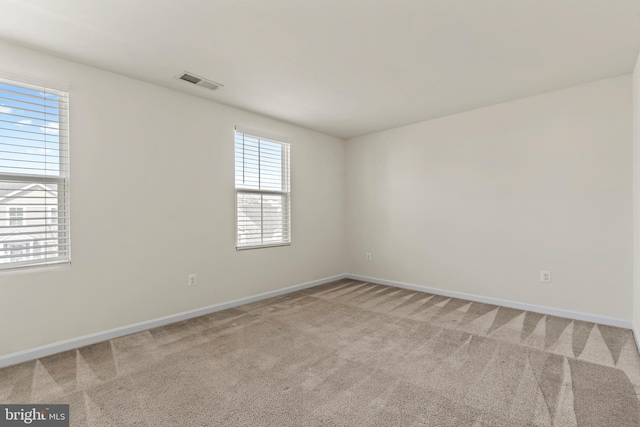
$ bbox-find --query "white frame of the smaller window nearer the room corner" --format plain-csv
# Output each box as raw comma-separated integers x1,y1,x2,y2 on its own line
234,127,292,251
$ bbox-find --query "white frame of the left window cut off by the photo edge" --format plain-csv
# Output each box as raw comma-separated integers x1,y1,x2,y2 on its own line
0,71,71,274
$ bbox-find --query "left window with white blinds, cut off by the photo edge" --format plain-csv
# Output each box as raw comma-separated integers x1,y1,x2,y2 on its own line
0,78,69,269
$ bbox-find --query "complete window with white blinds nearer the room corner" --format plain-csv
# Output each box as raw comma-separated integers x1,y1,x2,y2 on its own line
235,130,291,249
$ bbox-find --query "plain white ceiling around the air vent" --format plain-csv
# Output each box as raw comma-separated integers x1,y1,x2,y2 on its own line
0,0,640,138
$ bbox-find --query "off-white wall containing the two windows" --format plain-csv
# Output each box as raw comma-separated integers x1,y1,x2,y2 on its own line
0,42,345,355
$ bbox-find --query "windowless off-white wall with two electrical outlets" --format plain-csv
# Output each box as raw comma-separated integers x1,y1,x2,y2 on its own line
347,75,633,321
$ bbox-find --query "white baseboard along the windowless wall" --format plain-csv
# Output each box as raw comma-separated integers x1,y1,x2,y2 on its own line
346,274,638,332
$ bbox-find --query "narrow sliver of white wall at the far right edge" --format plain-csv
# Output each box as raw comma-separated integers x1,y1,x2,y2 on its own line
633,56,640,338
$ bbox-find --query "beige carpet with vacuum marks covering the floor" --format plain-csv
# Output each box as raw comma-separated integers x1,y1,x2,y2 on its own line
0,280,640,427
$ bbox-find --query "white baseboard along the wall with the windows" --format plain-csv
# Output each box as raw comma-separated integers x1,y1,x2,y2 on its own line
0,274,347,368
